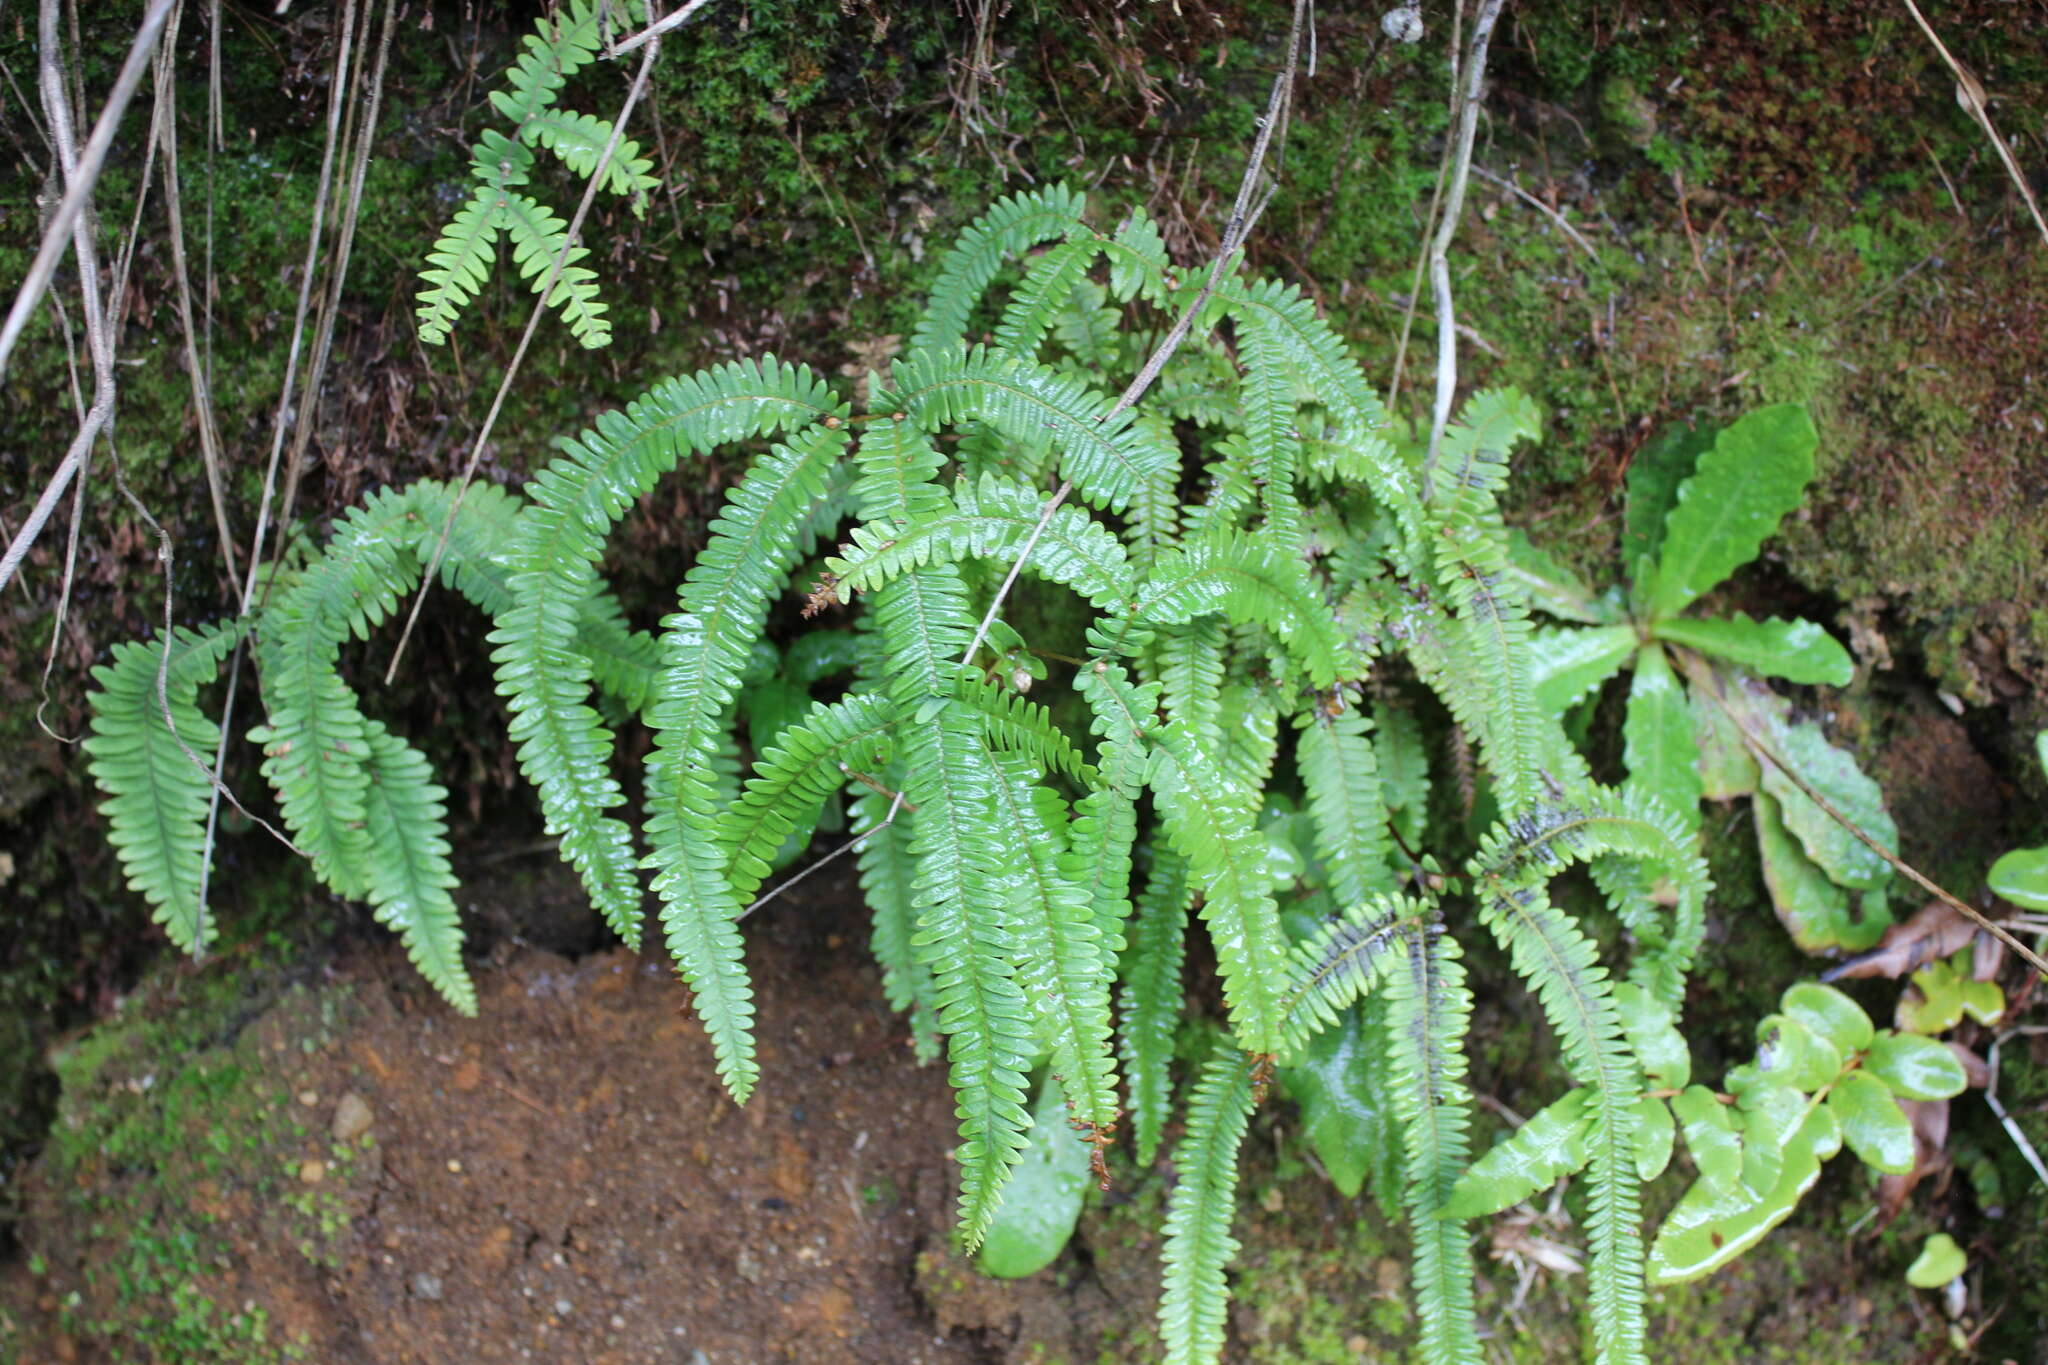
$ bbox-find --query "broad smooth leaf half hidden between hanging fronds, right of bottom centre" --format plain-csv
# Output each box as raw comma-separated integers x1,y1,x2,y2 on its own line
1280,999,1401,1205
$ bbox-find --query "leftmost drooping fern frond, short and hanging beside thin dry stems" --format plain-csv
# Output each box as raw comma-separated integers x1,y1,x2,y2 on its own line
86,624,242,954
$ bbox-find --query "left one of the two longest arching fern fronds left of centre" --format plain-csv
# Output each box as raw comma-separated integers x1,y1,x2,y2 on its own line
492,356,840,943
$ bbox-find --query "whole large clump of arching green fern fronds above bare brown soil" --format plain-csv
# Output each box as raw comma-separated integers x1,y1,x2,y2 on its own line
94,188,1744,1361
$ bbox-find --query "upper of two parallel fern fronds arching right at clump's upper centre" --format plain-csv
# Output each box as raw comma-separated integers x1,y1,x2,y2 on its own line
877,346,1161,512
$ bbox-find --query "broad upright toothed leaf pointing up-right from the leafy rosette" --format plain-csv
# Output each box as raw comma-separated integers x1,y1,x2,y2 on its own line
1651,403,1821,620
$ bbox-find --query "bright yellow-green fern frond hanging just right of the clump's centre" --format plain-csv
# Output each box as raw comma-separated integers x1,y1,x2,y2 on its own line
1151,724,1288,1054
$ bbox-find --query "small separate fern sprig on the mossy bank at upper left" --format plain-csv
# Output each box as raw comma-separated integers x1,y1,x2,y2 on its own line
418,0,659,348
